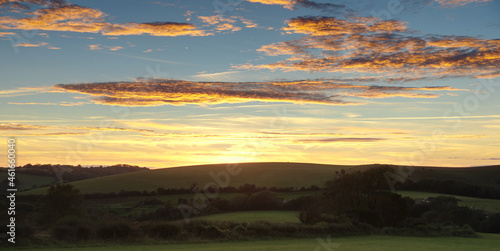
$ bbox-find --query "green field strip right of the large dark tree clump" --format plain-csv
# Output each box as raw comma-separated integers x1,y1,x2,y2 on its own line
397,191,500,213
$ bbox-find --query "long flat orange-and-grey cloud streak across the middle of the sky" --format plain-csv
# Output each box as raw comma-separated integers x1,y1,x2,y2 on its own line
53,79,460,106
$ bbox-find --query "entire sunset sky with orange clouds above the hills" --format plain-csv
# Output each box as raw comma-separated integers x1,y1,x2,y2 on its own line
0,0,500,168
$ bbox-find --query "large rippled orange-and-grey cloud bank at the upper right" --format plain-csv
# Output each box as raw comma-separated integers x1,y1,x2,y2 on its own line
239,17,500,78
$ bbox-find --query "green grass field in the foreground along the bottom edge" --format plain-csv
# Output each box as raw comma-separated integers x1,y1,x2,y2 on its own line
13,234,500,251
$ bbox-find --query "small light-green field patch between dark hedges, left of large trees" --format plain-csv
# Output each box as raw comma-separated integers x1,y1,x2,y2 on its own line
187,211,300,223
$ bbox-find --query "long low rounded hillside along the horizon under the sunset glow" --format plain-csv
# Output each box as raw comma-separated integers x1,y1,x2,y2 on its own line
21,162,500,194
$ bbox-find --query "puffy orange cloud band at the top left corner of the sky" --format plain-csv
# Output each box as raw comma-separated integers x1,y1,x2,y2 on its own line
0,4,209,36
